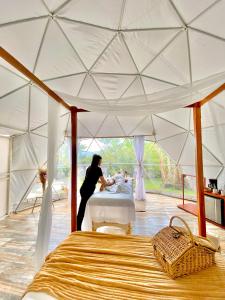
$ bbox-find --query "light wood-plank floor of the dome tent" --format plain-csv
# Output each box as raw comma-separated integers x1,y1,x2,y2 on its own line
0,194,225,300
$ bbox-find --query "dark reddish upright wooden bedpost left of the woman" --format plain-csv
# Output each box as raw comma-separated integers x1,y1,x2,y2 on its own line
70,106,77,232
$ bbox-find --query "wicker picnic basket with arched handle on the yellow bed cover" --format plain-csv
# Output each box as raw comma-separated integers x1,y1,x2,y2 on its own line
152,216,219,278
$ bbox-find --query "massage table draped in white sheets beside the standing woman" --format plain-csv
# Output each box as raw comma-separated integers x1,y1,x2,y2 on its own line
84,181,135,234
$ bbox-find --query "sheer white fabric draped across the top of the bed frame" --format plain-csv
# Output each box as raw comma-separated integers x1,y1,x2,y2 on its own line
58,72,225,116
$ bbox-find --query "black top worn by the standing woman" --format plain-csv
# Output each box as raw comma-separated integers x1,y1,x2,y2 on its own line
80,166,103,194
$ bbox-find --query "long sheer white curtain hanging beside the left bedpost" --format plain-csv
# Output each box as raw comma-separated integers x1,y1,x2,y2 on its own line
35,99,60,269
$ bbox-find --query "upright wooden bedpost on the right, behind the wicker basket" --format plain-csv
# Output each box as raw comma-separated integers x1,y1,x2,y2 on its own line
193,103,206,237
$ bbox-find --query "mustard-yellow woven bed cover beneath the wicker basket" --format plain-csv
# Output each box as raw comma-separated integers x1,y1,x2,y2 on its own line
24,232,225,300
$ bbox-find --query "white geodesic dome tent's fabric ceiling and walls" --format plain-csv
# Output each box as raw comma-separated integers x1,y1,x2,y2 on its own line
0,0,225,251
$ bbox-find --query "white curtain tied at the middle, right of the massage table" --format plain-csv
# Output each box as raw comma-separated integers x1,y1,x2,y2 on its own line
134,136,145,200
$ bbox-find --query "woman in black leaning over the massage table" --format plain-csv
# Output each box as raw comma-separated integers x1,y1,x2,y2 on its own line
77,154,111,230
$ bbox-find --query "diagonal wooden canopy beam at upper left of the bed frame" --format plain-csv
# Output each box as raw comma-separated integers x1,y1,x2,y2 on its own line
0,47,70,110
